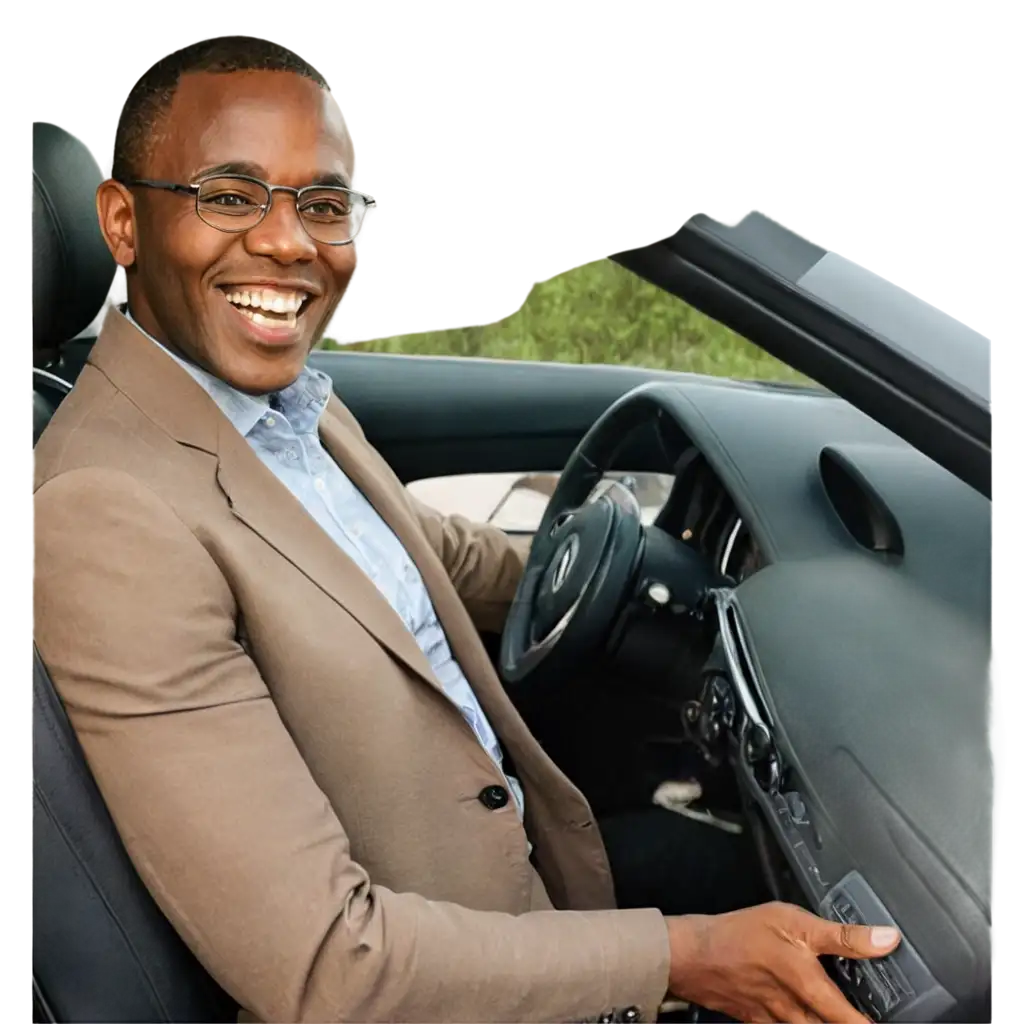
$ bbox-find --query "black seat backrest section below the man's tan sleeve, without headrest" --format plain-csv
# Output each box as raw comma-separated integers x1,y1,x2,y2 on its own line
33,652,238,1024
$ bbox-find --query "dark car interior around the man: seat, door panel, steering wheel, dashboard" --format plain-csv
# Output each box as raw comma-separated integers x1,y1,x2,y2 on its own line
29,123,992,1022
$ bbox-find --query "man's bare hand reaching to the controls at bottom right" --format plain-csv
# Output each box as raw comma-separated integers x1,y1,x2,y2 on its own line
668,903,900,1024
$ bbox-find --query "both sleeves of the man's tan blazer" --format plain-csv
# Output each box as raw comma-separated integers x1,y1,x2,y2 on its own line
33,469,669,1022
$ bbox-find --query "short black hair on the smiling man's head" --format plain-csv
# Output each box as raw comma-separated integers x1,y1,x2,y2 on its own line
106,32,331,181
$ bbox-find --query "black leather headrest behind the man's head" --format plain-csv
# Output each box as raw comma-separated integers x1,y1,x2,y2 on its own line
32,121,115,356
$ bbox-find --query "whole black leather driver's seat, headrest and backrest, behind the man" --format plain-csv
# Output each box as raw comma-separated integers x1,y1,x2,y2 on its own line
29,123,238,1024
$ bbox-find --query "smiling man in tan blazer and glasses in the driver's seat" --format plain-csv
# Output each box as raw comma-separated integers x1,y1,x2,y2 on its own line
33,36,898,1021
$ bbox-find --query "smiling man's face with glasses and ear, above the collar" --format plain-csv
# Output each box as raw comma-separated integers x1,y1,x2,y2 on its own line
97,50,360,394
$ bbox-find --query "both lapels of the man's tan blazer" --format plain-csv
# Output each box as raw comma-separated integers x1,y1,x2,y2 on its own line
89,303,544,757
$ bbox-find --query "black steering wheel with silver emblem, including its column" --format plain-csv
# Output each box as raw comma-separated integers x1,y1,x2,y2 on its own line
499,384,724,692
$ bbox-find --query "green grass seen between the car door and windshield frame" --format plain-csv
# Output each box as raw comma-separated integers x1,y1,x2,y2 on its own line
325,257,804,382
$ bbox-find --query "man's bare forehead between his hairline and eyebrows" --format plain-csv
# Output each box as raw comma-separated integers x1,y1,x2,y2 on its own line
152,71,349,185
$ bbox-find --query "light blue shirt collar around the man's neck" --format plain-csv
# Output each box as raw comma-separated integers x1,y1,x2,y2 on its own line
124,299,331,437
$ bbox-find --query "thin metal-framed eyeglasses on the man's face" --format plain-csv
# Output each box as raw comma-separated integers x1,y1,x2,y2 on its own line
123,174,377,246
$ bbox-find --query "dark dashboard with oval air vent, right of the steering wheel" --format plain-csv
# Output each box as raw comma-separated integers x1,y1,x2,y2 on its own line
643,383,995,1021
